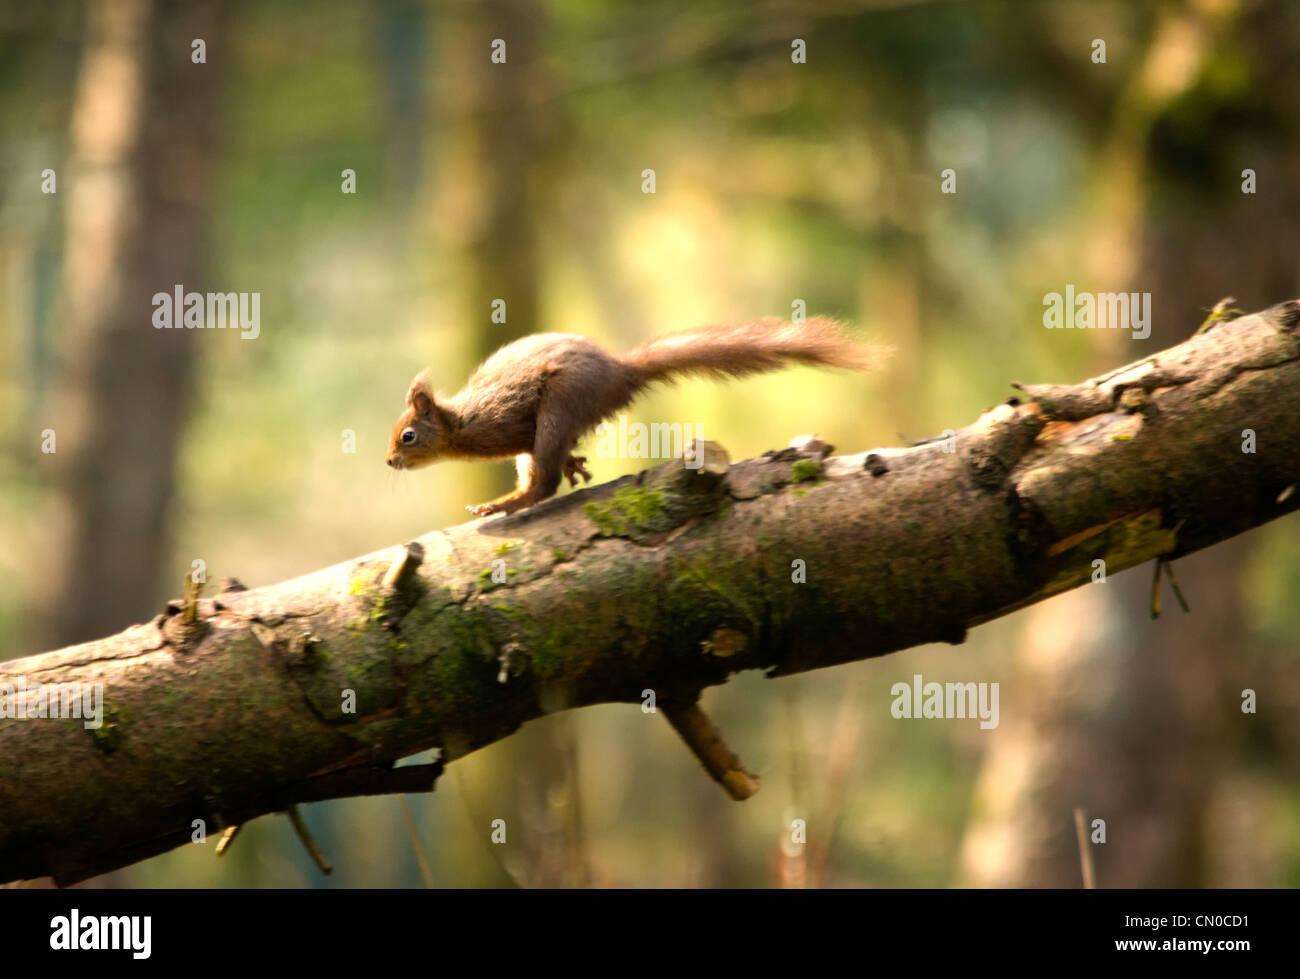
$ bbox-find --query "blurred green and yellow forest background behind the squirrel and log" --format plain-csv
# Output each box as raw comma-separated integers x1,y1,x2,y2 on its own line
0,0,1300,887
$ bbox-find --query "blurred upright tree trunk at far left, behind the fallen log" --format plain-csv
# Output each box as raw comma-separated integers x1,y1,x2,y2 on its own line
40,0,228,645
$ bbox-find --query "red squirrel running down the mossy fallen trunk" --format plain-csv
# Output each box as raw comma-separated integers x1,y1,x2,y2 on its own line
385,317,885,516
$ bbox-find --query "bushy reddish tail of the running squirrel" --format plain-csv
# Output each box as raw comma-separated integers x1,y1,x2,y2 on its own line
619,316,888,385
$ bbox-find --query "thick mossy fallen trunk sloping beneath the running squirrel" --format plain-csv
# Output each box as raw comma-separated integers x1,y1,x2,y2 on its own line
0,302,1300,884
